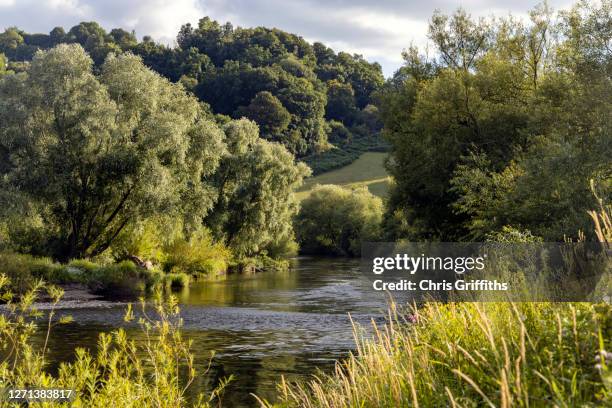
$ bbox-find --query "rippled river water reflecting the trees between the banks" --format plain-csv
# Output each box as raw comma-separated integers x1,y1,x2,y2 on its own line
40,258,386,407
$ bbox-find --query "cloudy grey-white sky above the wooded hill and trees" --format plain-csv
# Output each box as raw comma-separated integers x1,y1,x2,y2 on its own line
0,0,572,76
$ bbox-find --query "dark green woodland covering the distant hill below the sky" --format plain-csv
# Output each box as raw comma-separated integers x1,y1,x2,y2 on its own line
0,17,384,157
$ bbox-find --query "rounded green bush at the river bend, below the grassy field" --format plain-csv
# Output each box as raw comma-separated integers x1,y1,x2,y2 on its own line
294,185,383,256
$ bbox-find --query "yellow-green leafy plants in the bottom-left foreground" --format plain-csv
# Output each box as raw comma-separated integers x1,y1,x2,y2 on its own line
0,275,231,407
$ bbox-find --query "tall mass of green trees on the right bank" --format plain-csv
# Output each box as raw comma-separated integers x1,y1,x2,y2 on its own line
377,1,612,241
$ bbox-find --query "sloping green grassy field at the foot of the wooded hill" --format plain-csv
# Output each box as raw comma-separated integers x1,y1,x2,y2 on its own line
297,152,390,200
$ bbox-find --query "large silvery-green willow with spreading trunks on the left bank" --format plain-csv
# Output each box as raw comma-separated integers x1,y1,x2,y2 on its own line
0,45,223,259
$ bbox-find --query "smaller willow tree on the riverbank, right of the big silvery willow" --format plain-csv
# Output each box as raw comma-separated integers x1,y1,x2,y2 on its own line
206,119,310,256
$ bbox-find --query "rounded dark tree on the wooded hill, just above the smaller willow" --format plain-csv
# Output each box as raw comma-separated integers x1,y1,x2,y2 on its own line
234,91,291,140
